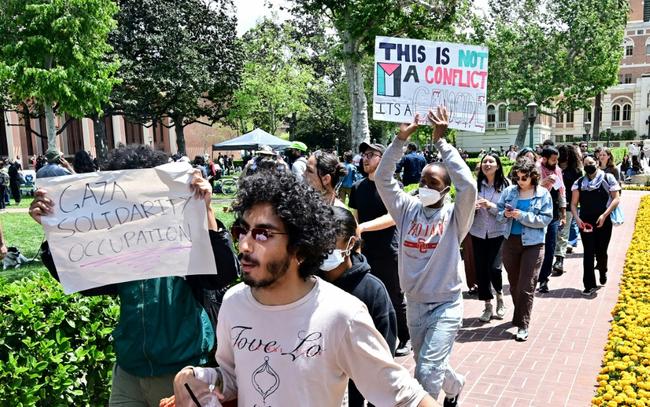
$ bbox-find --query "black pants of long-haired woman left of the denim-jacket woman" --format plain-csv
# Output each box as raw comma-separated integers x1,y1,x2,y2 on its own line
472,236,503,301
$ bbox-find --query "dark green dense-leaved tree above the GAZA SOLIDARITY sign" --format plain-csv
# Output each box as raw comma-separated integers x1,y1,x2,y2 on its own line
110,0,242,153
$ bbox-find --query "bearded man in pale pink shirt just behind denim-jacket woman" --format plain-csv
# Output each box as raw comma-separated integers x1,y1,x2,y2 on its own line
537,147,566,293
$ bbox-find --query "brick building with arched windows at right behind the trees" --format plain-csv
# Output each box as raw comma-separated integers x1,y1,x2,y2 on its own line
457,0,650,151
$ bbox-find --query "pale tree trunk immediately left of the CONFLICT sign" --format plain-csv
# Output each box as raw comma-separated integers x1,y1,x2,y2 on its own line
343,32,370,150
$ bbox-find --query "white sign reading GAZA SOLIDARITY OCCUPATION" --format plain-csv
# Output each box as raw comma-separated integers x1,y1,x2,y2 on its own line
36,163,216,294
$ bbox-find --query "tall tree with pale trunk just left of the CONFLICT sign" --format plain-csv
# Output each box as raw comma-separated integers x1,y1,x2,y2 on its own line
292,0,460,150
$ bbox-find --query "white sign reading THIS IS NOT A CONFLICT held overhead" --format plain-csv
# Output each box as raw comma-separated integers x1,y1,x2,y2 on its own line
372,37,488,133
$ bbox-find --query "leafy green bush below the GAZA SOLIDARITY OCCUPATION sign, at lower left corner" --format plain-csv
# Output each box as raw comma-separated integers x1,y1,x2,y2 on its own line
0,272,119,406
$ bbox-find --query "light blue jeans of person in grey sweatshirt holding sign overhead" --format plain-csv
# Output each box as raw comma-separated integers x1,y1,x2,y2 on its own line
406,297,465,398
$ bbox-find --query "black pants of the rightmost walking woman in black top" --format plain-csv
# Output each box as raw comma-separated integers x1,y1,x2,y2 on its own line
580,216,612,289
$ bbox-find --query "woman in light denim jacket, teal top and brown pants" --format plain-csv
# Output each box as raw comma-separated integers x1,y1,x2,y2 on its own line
497,158,553,342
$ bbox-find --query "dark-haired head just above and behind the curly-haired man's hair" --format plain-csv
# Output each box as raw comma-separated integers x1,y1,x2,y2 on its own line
304,150,347,208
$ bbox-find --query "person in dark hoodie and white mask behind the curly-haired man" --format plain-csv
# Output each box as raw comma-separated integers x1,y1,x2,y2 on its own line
320,206,397,407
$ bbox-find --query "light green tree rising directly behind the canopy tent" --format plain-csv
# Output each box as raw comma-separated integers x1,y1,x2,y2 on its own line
229,19,315,134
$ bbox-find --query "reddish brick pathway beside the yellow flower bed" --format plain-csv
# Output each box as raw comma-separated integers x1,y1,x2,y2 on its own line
398,191,647,407
